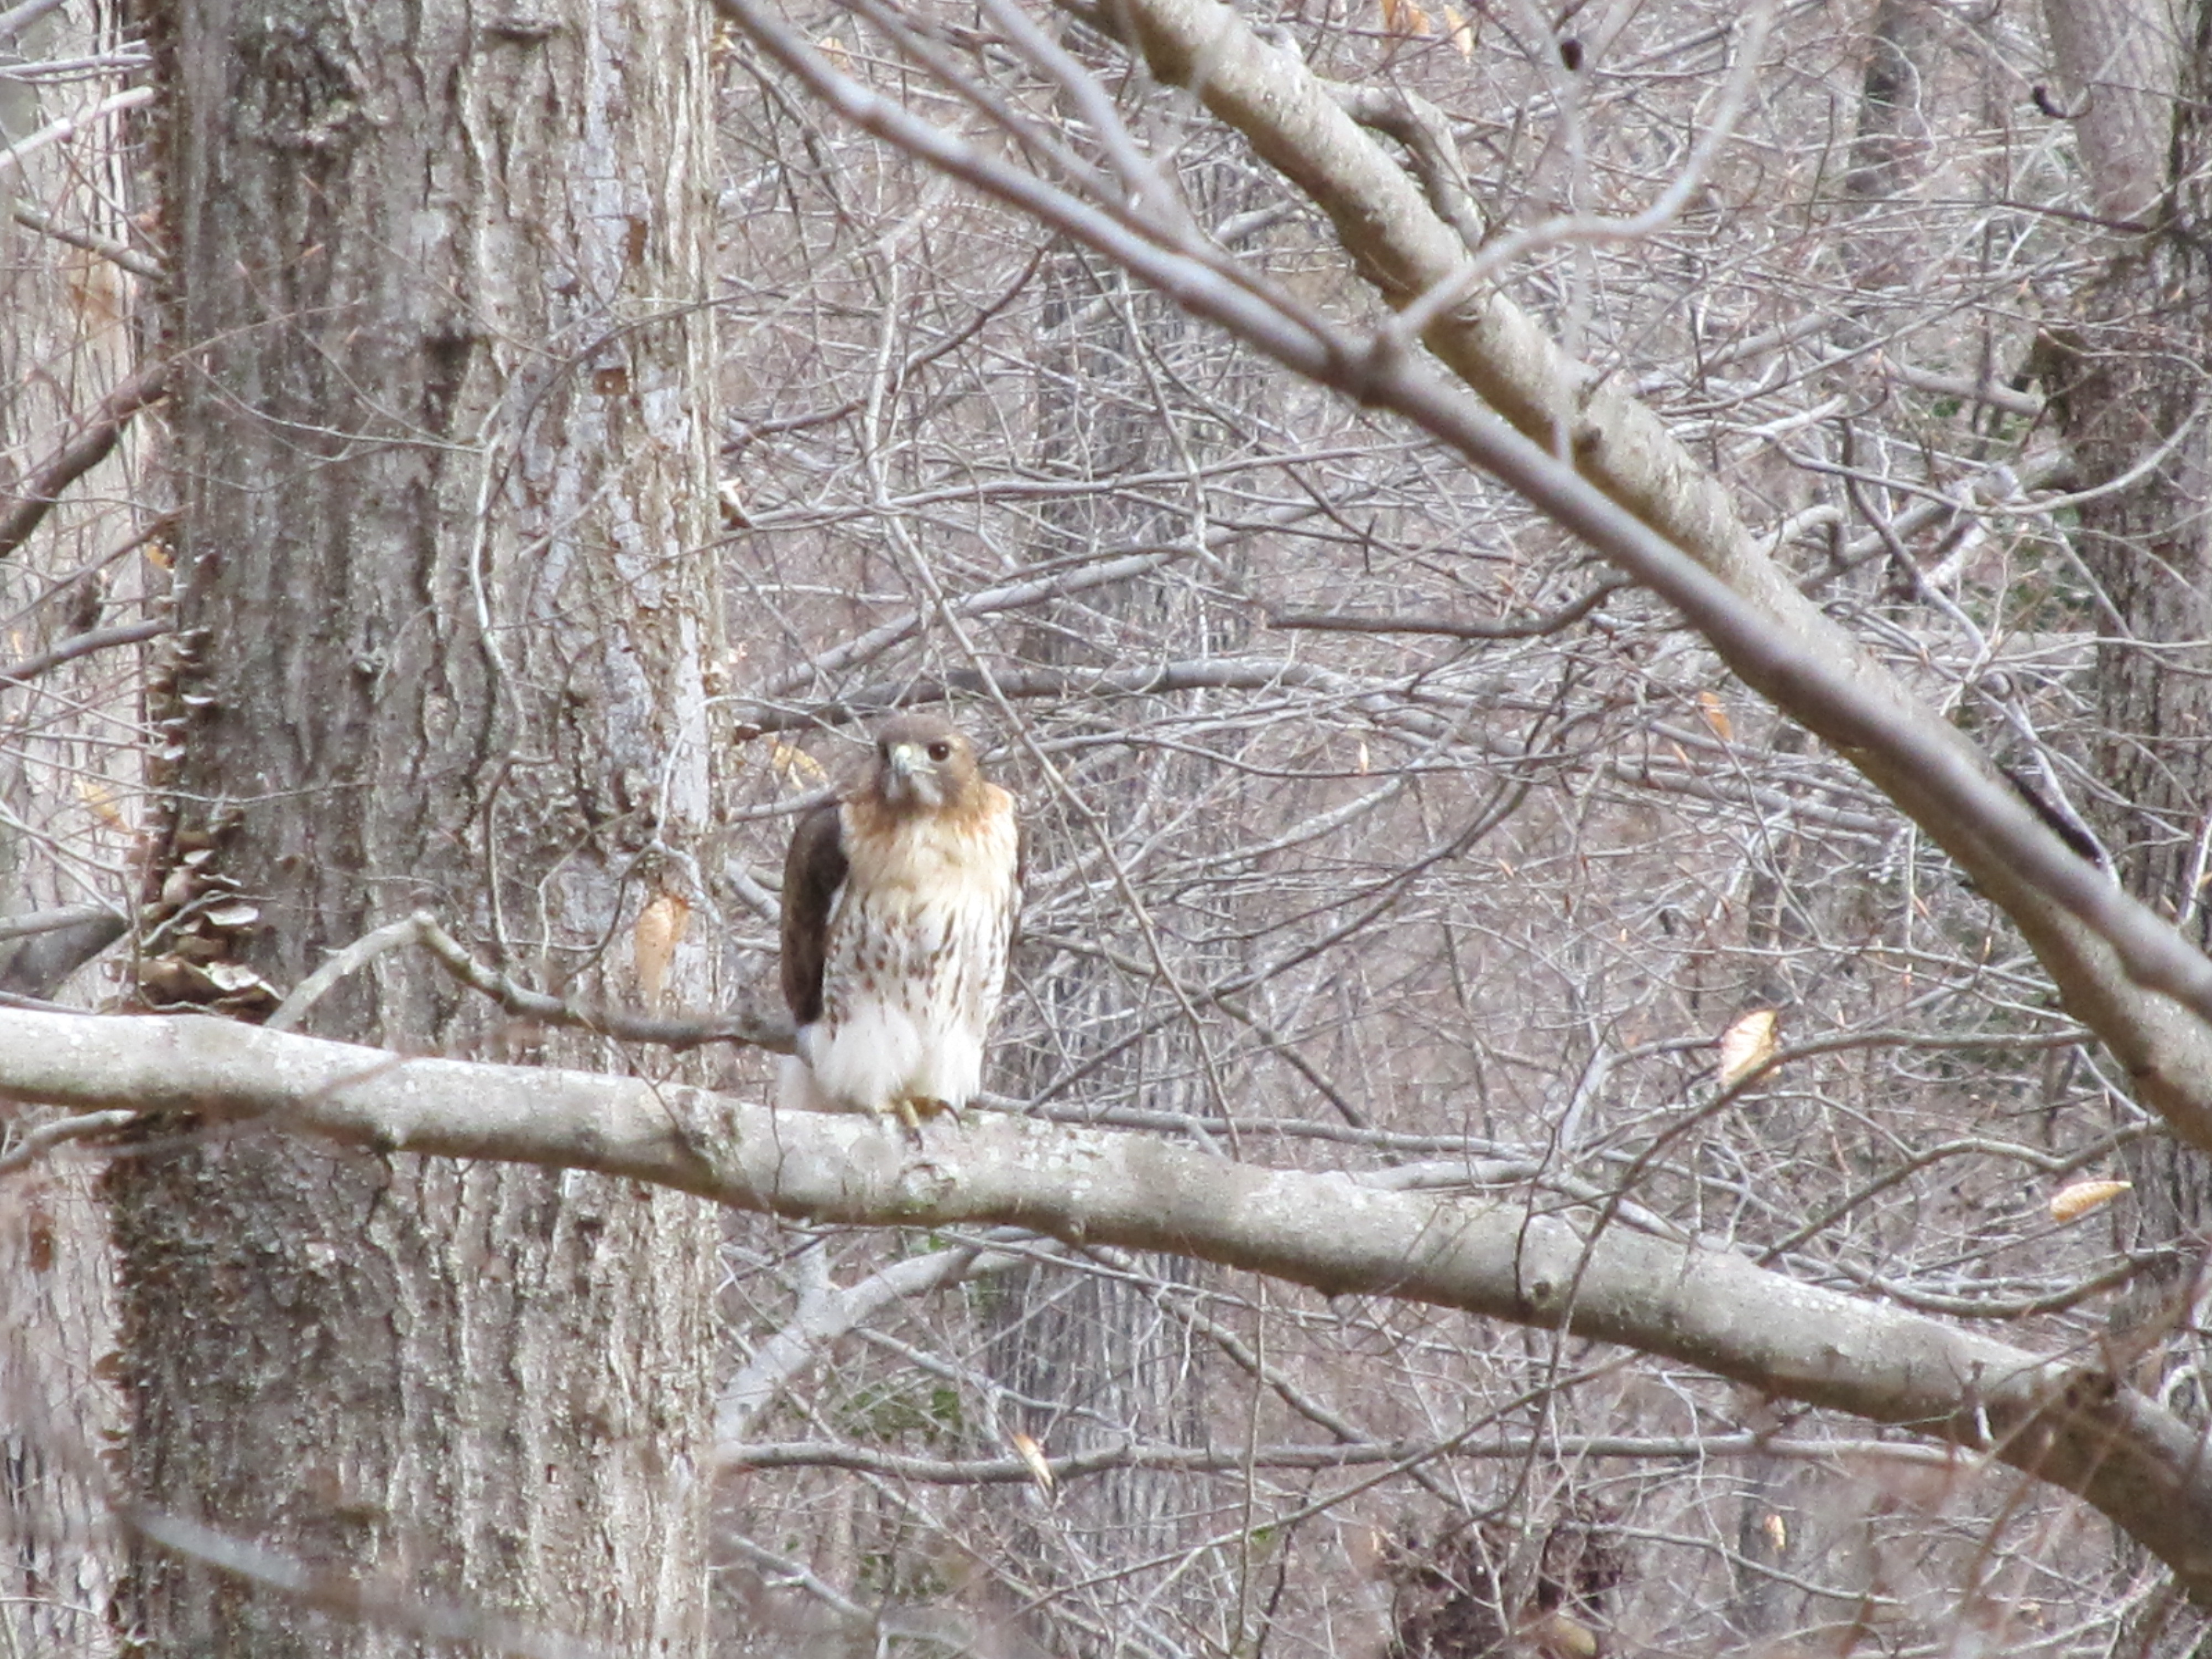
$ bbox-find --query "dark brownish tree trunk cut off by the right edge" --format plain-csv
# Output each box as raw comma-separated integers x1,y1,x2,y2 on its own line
2039,0,2212,1409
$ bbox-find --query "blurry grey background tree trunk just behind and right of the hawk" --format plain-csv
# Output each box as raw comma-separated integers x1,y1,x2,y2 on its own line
989,248,1214,1652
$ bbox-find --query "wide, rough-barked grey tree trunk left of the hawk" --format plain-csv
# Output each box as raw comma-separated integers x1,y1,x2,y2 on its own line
113,0,717,1659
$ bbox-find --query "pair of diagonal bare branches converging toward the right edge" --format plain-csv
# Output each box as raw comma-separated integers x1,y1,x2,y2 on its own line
714,0,2212,1150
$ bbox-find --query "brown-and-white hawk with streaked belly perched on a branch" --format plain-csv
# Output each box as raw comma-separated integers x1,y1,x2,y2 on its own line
779,714,1022,1130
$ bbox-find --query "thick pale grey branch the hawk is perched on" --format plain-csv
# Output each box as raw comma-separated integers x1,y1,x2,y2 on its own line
0,1011,2212,1599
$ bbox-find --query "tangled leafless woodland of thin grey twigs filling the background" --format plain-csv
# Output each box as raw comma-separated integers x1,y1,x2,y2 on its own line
0,0,2208,1659
